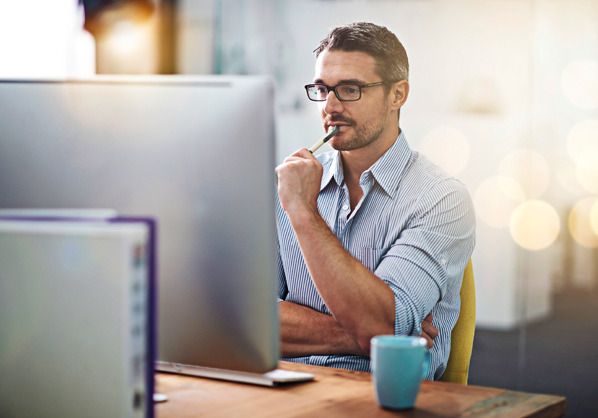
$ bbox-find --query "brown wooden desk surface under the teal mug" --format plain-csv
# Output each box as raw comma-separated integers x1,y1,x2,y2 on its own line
156,363,565,418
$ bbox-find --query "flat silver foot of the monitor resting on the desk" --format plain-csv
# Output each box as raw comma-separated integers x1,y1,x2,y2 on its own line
156,361,315,386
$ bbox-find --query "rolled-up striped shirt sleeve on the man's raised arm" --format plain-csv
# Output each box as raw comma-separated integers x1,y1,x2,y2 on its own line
375,179,475,335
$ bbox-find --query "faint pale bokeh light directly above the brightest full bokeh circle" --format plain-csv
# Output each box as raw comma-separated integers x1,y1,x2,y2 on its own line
498,149,550,197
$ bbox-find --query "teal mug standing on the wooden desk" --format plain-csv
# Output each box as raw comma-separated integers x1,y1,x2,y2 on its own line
370,335,430,409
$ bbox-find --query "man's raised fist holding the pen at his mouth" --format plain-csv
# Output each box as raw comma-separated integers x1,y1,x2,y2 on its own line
276,148,324,216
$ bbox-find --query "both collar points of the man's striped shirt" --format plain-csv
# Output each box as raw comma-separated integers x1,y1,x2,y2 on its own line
320,130,413,197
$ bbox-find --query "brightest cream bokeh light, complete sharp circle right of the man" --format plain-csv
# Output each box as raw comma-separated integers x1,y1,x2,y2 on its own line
509,199,561,251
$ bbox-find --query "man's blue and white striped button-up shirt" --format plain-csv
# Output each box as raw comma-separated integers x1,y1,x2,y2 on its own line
277,132,475,379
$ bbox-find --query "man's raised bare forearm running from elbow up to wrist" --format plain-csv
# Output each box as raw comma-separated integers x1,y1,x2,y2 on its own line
290,208,395,352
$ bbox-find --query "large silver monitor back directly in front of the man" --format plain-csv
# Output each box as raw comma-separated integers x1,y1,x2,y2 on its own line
0,76,279,372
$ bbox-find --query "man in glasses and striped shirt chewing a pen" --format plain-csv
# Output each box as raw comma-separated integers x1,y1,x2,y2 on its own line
276,23,475,379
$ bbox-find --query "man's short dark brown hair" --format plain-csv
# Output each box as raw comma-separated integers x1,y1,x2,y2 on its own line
314,22,409,82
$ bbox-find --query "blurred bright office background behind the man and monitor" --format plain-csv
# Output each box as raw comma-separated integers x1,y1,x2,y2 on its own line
0,0,598,417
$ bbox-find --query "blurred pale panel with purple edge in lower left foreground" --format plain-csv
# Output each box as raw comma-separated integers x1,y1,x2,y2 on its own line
0,217,155,418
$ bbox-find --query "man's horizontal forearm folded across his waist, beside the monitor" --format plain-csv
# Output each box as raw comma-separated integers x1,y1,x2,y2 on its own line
278,302,369,357
